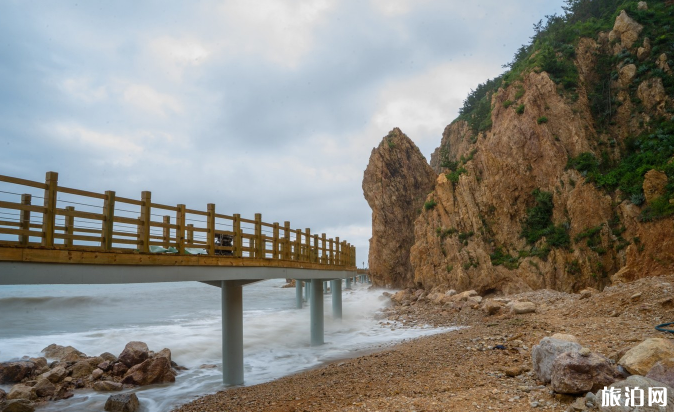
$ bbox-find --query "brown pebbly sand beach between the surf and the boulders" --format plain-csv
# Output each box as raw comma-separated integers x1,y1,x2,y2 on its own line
175,276,674,412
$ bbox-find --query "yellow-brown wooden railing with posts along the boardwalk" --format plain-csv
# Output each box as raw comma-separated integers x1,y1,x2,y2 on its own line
0,172,356,267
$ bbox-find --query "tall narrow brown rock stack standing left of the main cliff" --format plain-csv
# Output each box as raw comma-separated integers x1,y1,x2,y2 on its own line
363,128,436,287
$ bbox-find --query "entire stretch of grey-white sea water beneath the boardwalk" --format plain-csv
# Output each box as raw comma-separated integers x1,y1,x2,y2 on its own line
0,280,451,412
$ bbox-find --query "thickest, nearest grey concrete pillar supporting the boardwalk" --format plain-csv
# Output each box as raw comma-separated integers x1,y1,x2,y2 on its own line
221,280,243,385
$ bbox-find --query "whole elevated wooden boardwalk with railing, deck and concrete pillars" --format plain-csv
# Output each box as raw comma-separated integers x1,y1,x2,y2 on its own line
0,172,356,385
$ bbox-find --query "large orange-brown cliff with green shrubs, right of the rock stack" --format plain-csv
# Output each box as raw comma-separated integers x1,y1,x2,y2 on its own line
366,2,674,294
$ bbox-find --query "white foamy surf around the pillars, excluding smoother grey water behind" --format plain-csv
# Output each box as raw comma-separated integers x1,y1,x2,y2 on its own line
0,280,454,412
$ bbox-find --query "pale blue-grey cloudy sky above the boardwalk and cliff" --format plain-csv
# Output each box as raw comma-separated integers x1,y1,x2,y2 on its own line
0,0,562,265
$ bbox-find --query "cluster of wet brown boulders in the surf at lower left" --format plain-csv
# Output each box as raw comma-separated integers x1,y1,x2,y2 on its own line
0,342,185,412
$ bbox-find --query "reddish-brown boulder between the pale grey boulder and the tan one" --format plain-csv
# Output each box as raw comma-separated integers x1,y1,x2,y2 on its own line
551,352,615,394
